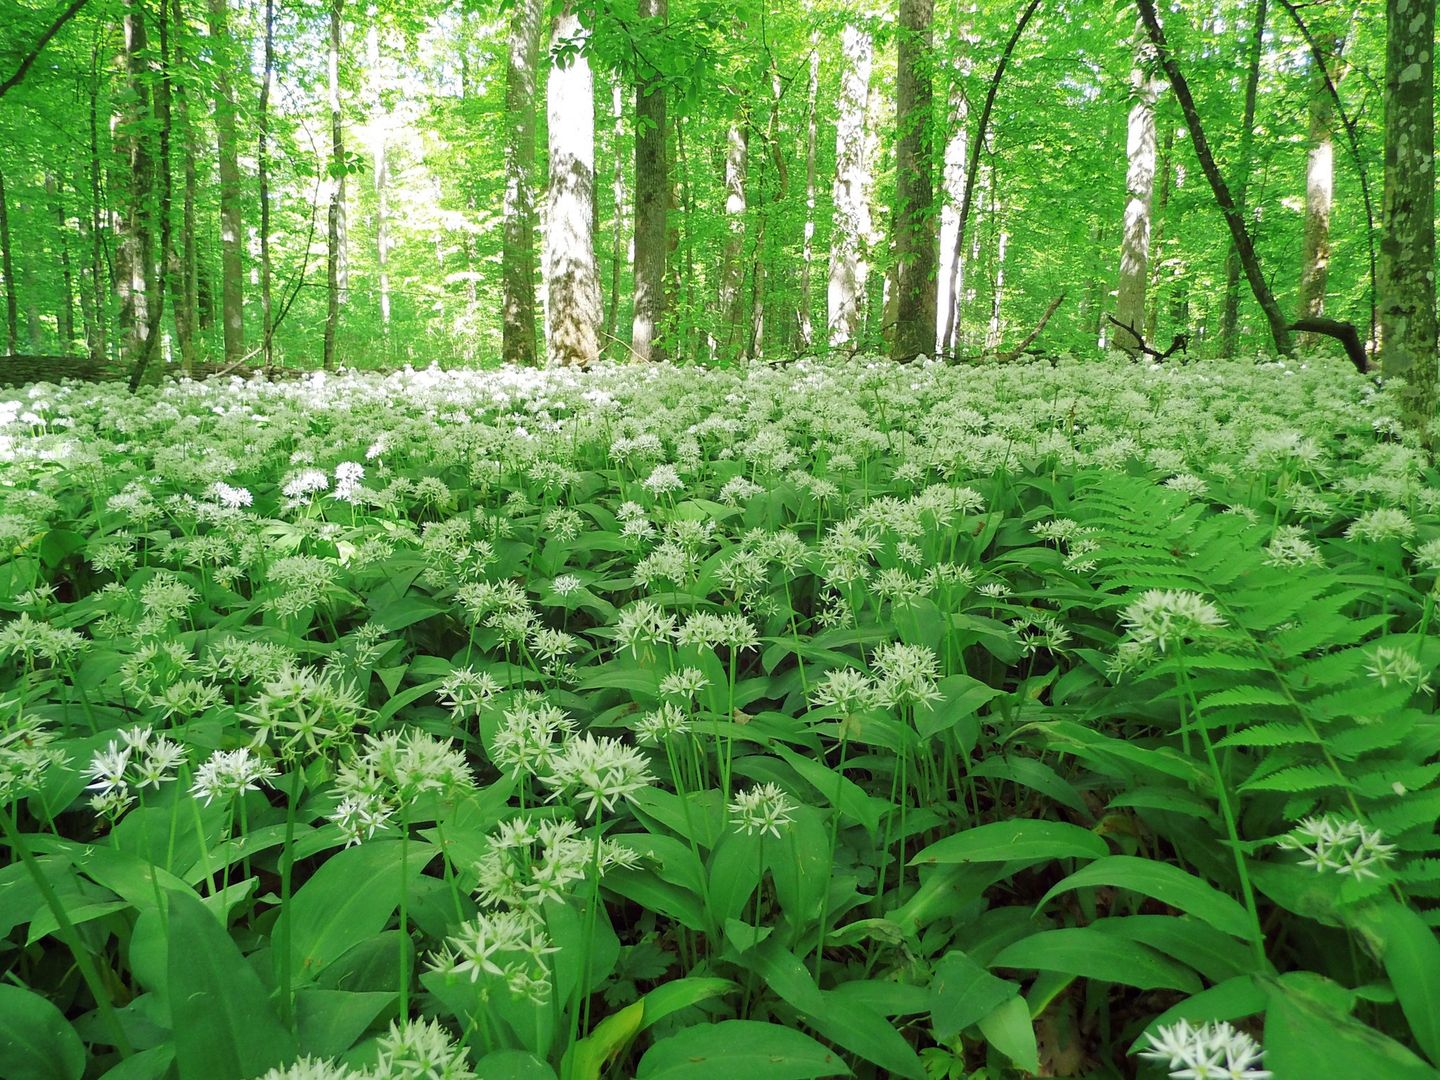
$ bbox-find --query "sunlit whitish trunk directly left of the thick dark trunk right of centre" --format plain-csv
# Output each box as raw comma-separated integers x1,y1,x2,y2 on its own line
825,26,874,347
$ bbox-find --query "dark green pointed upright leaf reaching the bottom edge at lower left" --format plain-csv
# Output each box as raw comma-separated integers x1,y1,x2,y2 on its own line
167,893,295,1080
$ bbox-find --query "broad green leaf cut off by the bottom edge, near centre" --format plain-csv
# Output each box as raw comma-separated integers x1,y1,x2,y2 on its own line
635,1020,851,1080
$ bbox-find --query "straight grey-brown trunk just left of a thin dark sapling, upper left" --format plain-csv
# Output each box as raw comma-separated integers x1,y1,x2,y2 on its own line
209,0,245,364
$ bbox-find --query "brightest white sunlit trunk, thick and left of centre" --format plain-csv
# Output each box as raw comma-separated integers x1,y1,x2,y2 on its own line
544,3,601,367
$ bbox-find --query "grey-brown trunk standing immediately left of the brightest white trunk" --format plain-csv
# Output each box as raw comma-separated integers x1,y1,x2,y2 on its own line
500,0,541,367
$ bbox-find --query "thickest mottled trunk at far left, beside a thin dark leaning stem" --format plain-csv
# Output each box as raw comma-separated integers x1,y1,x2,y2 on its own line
115,0,154,370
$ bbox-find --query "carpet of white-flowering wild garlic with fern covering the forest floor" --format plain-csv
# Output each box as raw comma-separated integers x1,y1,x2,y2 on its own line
0,360,1440,1080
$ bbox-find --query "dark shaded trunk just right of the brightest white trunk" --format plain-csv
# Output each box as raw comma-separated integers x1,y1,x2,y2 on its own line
631,0,671,360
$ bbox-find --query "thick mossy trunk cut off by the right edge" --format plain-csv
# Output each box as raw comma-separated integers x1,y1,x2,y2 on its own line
1380,0,1437,434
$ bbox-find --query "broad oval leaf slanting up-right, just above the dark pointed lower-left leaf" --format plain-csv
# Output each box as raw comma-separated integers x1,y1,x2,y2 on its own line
275,840,425,984
